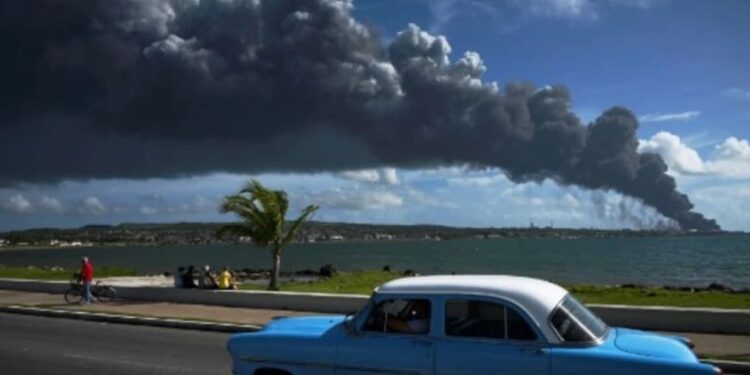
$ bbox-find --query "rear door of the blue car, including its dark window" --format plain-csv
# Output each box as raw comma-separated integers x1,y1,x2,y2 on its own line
435,296,550,375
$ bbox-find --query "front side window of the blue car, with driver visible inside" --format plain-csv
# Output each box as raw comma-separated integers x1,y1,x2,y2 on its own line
362,298,432,335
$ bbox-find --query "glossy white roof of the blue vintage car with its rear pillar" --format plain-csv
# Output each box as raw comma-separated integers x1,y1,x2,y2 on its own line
376,275,568,341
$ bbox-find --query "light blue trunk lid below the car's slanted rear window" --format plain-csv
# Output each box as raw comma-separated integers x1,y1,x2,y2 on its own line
615,328,697,362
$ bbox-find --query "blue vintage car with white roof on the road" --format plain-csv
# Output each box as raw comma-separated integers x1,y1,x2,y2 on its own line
228,276,721,375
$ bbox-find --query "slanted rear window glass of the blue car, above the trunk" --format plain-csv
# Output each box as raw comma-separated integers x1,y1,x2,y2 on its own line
550,296,607,343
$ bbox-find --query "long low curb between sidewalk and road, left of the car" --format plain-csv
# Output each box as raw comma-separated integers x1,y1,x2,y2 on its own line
0,305,260,333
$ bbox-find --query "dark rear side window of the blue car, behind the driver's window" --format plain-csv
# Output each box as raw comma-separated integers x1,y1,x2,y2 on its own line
445,299,537,341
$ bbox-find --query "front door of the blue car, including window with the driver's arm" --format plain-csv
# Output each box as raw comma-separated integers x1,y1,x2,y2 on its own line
336,296,434,375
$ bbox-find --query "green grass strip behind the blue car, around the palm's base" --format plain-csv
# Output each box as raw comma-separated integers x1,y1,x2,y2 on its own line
240,271,750,309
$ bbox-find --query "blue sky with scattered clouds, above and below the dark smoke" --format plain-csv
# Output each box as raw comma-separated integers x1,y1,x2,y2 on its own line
0,0,750,230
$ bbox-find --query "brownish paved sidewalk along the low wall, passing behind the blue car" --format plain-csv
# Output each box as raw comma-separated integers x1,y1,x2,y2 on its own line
0,290,750,358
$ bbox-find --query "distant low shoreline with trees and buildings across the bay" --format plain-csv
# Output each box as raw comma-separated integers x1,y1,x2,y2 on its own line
0,221,732,246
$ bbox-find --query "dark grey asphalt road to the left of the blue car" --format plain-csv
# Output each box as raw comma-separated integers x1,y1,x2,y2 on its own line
0,313,231,375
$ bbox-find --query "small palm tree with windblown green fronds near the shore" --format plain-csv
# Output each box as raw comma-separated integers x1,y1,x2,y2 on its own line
218,180,318,290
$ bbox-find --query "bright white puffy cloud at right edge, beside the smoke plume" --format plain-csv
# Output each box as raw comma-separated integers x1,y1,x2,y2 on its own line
638,132,750,179
